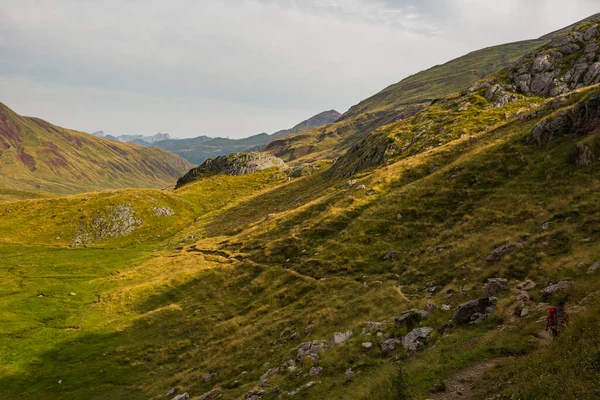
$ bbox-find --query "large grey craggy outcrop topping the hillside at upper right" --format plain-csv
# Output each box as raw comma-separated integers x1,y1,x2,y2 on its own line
509,22,600,97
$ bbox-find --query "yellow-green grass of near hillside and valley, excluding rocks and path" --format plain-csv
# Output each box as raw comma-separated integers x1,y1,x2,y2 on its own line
0,83,600,399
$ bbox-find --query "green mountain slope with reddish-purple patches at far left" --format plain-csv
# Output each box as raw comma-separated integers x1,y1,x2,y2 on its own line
0,103,192,193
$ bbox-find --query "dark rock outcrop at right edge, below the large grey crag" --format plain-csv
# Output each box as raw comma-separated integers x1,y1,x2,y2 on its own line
527,95,600,147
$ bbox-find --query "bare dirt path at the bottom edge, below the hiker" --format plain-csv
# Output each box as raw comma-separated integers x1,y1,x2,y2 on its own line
431,358,506,400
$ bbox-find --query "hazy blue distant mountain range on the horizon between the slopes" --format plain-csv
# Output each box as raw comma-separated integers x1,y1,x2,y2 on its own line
92,110,342,164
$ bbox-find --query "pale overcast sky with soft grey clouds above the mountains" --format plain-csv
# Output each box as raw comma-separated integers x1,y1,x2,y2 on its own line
0,0,600,138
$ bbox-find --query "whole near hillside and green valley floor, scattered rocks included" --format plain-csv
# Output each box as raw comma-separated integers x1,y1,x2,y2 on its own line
0,14,600,400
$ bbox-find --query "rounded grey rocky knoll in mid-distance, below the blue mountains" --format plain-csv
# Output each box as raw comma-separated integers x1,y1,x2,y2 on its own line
176,153,286,188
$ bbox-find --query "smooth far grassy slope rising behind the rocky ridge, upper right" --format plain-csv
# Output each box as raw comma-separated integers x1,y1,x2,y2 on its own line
267,38,550,163
